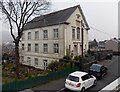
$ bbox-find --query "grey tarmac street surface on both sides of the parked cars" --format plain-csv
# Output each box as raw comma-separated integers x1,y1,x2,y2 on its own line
31,56,120,92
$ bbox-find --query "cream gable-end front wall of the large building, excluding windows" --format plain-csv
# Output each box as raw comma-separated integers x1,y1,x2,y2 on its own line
66,8,88,55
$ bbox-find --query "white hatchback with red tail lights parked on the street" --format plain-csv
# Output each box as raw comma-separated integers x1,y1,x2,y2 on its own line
65,71,97,92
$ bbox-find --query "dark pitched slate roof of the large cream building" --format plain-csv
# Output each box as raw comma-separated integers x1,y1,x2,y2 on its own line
24,5,89,30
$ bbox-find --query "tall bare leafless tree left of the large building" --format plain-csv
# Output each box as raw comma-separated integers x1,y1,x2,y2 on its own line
0,0,50,78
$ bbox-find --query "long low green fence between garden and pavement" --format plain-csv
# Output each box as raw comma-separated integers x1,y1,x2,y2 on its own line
2,67,80,92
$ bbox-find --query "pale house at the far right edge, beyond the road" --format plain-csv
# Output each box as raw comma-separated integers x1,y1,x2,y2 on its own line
105,38,120,52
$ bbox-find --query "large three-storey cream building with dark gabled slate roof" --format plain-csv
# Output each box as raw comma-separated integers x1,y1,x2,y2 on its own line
20,5,89,70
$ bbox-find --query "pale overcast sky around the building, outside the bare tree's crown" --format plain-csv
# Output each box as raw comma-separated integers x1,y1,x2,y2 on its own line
0,0,118,41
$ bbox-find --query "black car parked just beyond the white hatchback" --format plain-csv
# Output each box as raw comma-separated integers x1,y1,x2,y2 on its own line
88,64,108,79
